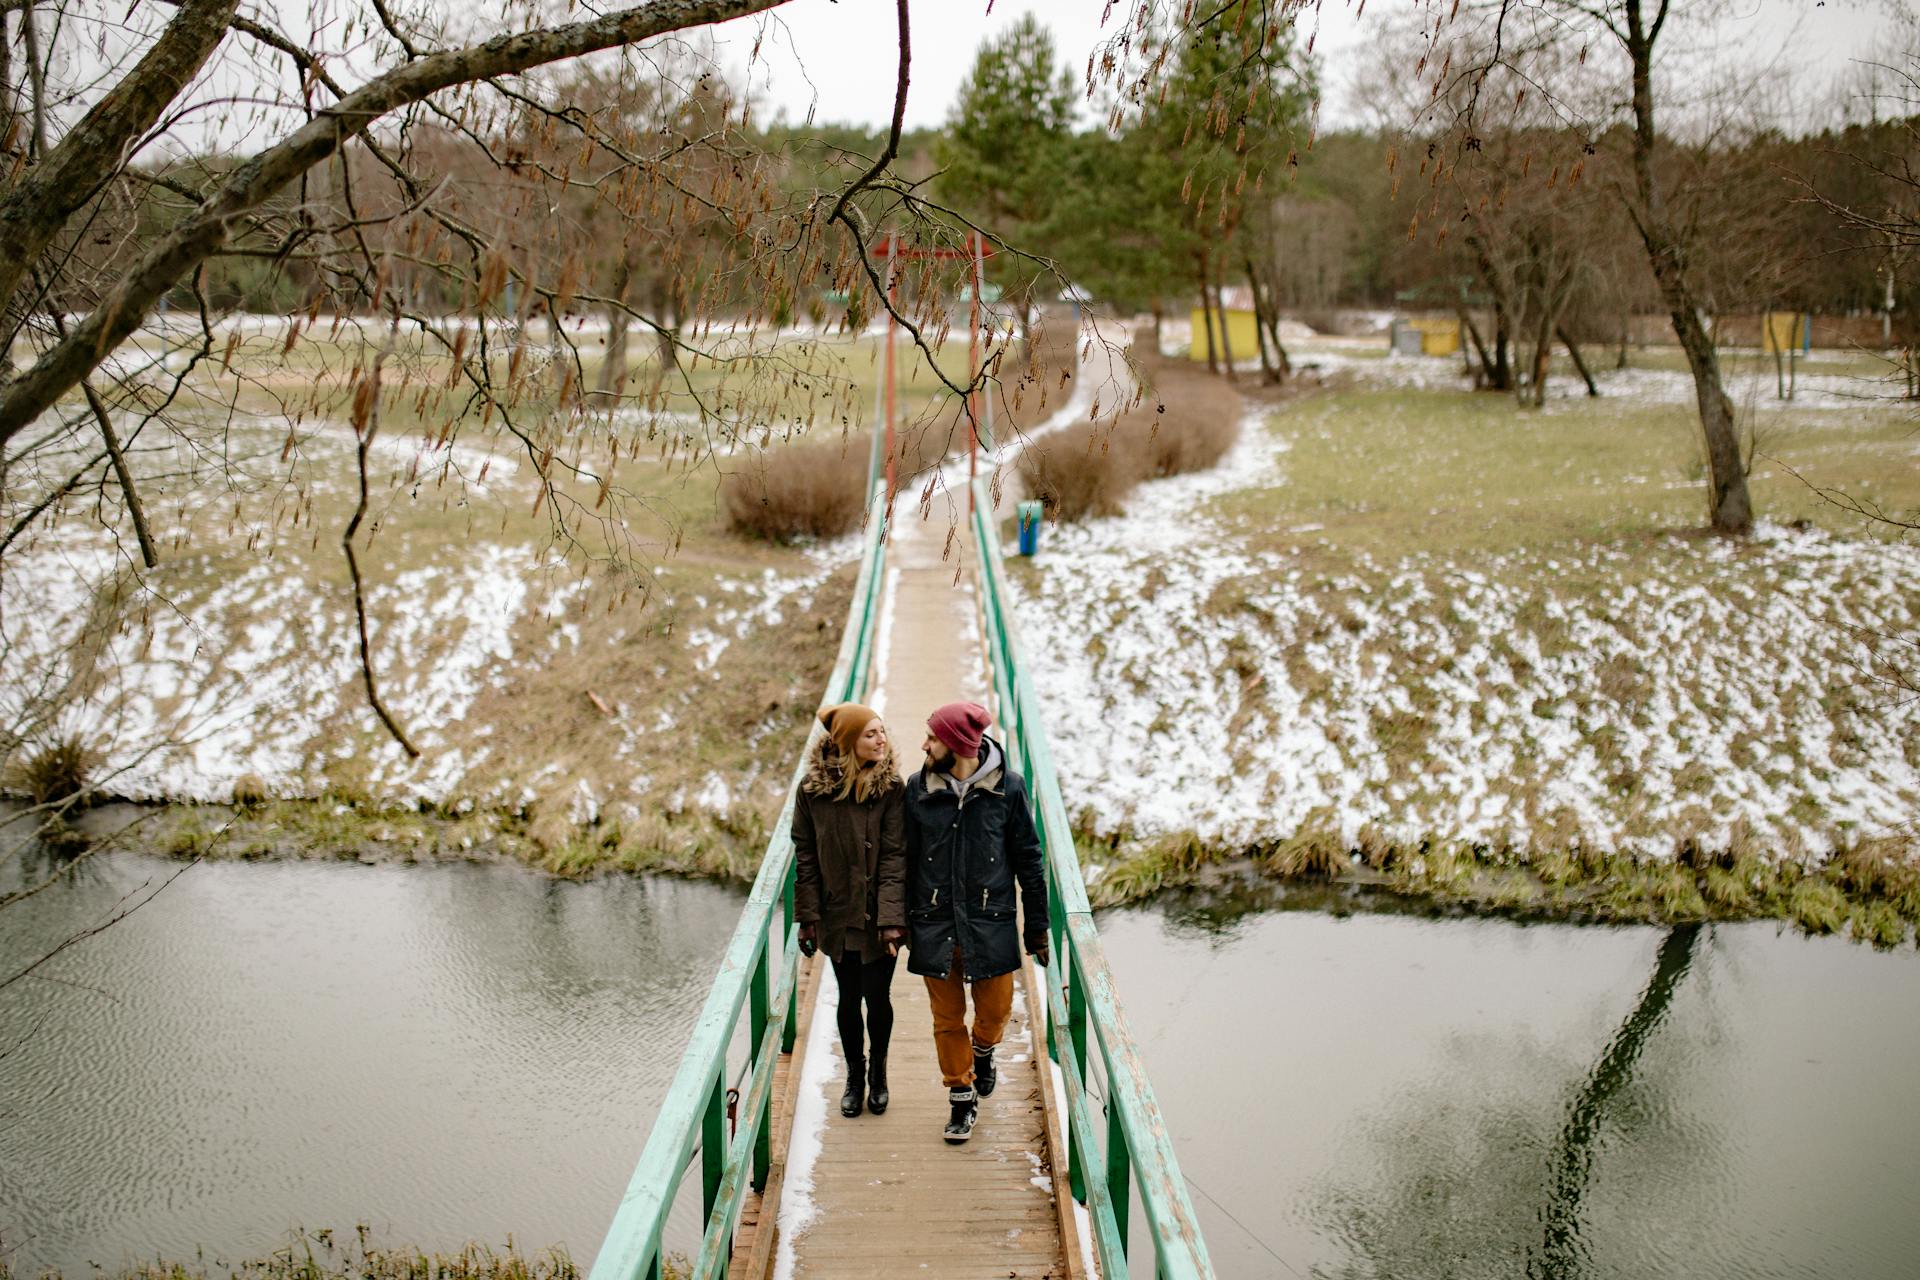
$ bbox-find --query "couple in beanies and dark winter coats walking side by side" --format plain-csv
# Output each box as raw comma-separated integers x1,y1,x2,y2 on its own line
793,702,1048,1142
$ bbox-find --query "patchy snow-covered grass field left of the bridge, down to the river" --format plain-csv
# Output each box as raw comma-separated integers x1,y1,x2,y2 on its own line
0,317,1071,875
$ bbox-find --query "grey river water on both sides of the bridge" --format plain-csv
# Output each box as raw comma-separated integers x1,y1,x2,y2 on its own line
0,854,1920,1278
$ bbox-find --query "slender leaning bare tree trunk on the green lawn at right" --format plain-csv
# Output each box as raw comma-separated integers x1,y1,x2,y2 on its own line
1626,0,1753,535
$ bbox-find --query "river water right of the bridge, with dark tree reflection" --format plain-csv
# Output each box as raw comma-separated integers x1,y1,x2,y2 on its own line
1100,894,1920,1278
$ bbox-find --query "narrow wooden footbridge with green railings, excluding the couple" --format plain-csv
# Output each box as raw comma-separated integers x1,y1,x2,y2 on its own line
572,314,1213,1280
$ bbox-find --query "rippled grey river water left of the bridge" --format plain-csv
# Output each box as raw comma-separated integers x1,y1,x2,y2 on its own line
0,854,739,1274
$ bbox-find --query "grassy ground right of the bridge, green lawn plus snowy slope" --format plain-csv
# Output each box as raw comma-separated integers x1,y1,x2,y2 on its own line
1014,370,1920,940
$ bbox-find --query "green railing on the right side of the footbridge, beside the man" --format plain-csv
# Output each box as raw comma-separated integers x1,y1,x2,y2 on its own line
967,480,1213,1280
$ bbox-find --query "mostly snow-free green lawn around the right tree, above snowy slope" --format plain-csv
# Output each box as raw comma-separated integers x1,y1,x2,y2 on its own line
1215,390,1920,557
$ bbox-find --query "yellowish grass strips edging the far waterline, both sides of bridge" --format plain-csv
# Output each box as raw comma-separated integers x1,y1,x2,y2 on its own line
18,796,1920,948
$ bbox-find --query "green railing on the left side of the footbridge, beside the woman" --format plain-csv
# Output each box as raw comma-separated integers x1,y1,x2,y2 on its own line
588,489,885,1280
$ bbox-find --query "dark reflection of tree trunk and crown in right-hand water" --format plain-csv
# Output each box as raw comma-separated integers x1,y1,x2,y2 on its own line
1309,925,1715,1280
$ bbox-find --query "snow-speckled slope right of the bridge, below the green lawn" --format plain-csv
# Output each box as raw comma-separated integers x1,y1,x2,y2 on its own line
1014,416,1920,856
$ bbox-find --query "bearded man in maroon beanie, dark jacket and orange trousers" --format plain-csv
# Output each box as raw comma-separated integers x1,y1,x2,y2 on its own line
906,702,1048,1142
